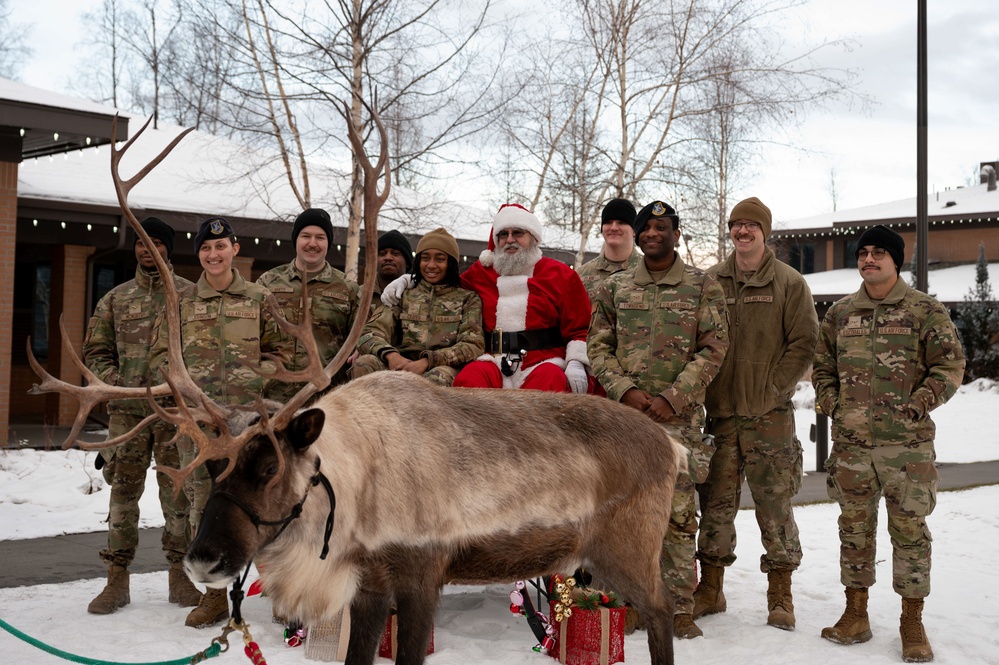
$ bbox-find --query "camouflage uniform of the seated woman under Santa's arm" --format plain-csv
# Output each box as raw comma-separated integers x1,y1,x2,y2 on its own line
353,280,485,386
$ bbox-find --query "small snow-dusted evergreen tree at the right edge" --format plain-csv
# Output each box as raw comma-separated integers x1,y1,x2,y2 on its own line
957,242,999,383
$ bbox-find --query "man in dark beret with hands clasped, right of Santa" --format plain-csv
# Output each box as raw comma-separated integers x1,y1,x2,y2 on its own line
587,201,728,638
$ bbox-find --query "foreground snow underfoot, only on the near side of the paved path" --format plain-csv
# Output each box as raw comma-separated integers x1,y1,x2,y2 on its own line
0,486,999,665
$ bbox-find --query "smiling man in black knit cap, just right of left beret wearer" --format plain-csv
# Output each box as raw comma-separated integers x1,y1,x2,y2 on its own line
257,208,358,402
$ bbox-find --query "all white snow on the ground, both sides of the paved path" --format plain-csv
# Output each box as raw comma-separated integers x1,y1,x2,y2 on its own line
0,381,999,665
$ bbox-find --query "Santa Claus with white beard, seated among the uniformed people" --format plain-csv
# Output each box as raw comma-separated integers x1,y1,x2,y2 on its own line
382,204,596,393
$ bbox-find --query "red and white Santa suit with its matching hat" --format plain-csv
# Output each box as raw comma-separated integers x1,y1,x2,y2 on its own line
454,205,590,392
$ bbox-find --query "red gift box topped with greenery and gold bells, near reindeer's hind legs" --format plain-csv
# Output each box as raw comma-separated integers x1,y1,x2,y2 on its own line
549,601,625,665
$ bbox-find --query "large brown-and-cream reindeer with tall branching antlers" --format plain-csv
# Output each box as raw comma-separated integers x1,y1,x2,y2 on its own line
29,104,686,665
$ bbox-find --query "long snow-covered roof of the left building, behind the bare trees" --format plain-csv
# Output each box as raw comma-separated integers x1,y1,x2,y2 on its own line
18,118,599,252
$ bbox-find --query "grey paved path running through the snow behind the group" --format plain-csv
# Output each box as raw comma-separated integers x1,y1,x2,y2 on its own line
0,427,999,588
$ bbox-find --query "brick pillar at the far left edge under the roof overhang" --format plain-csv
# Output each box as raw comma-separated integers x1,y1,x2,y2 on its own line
0,162,17,444
